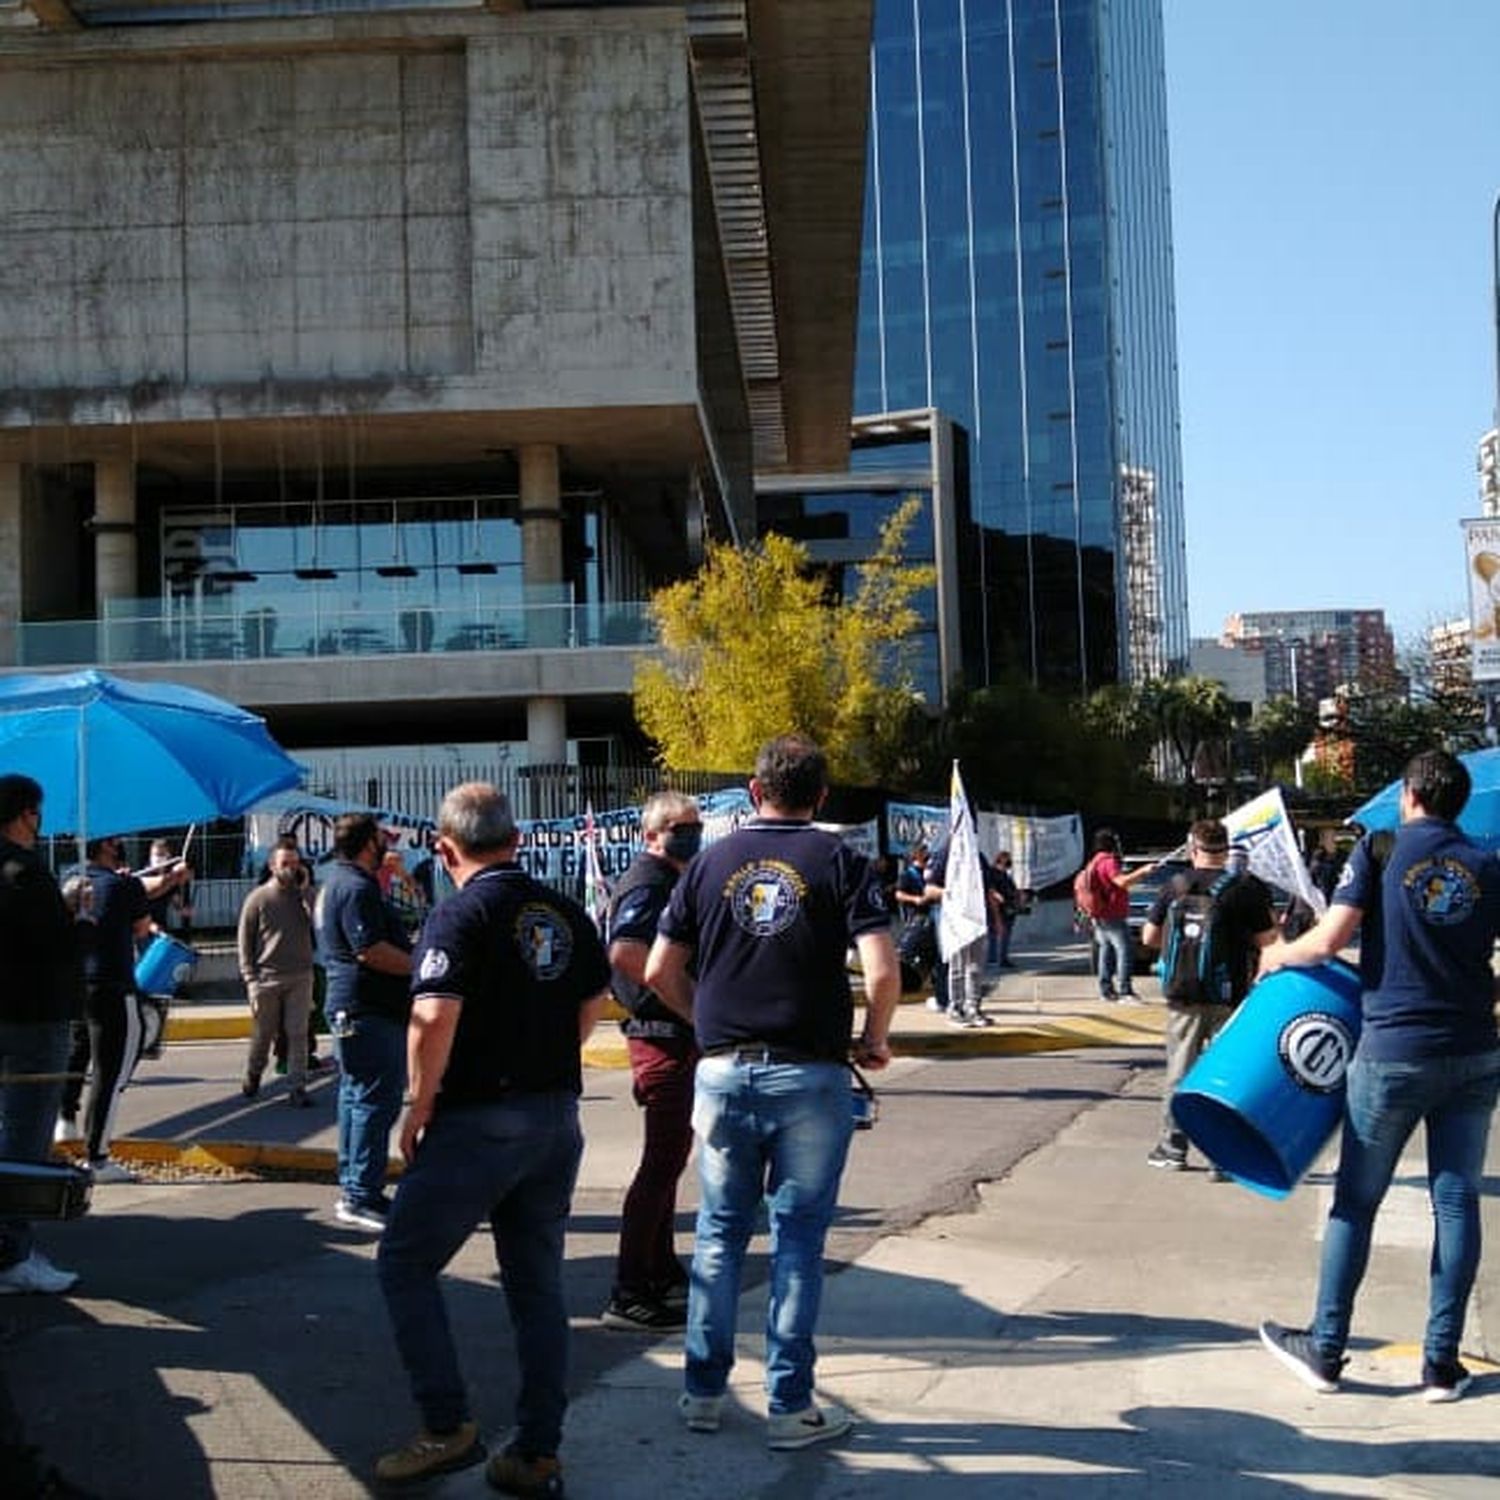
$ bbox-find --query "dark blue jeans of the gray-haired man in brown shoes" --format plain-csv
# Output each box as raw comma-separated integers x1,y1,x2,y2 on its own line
377,1094,584,1457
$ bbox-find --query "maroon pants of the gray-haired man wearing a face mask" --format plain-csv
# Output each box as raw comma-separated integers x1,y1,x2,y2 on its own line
615,1037,698,1298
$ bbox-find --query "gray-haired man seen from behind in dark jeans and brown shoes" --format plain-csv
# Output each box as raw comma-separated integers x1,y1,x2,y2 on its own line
375,782,609,1496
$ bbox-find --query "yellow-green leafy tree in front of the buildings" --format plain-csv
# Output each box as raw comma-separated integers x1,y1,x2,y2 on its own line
635,498,935,783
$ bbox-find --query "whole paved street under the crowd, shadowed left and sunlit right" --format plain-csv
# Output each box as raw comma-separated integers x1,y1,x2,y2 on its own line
0,930,1500,1500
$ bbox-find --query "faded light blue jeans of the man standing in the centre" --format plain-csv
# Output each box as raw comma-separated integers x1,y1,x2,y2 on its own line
686,1058,854,1415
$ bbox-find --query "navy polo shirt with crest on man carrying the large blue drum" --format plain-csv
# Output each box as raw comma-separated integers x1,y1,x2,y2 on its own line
1334,818,1500,1062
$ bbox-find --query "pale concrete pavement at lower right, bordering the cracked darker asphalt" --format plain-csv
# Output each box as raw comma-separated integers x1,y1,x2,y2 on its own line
564,1074,1500,1500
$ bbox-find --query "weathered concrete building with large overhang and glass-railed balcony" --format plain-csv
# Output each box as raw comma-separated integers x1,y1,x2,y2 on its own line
0,0,872,804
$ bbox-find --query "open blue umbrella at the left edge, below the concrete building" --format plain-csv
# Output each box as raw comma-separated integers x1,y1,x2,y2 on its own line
0,669,302,839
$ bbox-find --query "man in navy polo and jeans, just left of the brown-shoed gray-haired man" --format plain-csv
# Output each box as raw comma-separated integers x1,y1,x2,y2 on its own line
314,813,411,1235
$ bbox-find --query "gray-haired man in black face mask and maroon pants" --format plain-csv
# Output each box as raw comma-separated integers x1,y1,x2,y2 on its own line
603,792,704,1332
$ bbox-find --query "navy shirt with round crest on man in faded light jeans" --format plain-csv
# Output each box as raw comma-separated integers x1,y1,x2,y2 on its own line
660,819,891,1062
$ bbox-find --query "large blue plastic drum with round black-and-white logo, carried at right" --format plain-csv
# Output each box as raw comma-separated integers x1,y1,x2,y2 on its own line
1172,962,1361,1199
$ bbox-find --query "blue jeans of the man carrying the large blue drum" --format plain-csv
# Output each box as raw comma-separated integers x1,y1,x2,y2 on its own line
1313,1052,1500,1364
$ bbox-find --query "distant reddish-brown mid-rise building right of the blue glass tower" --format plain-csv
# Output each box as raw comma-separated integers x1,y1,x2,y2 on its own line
1221,609,1403,708
